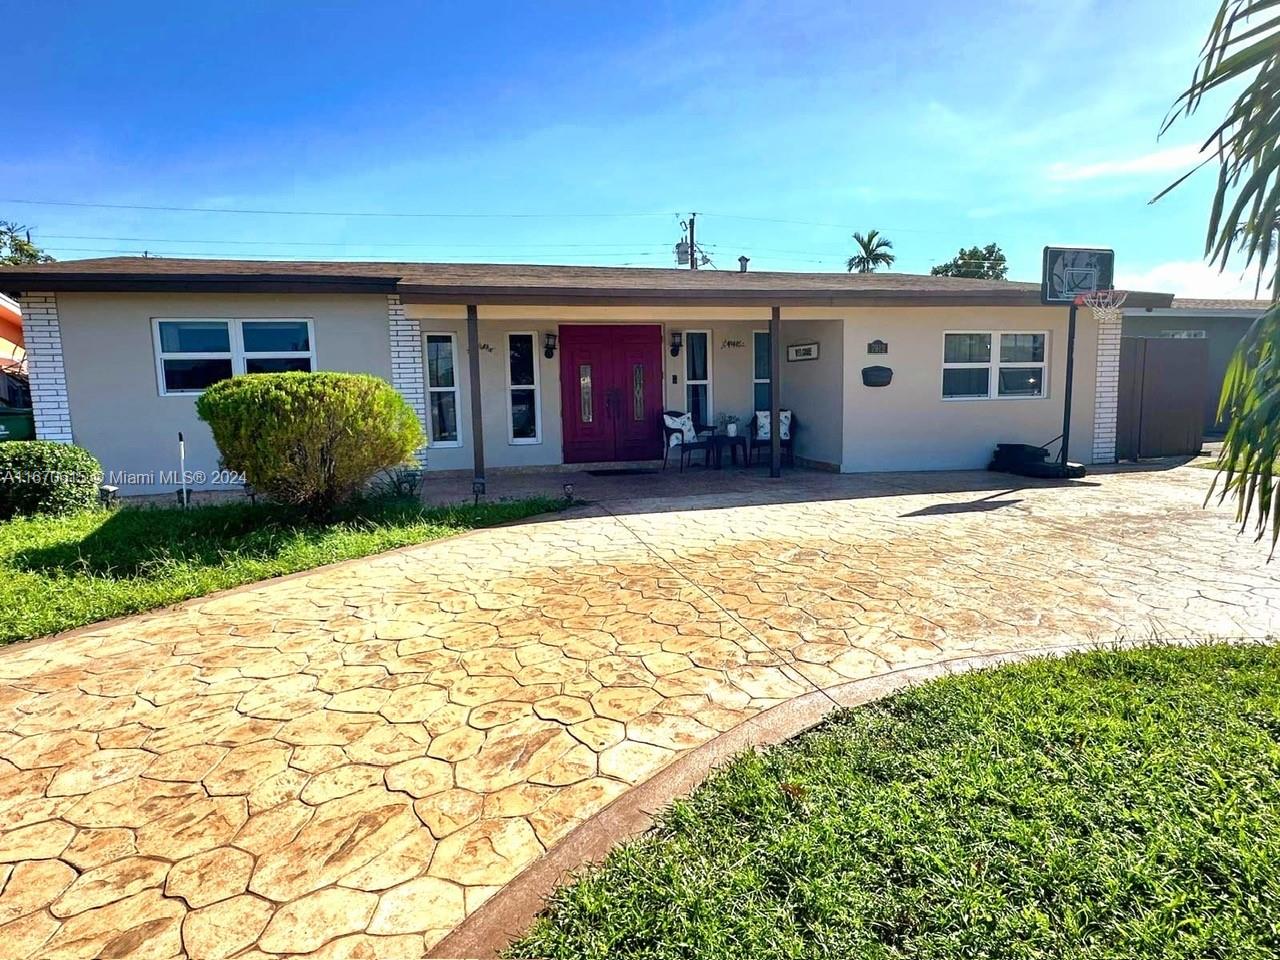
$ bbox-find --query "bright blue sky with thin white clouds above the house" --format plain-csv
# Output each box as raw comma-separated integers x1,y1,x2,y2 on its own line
0,0,1247,294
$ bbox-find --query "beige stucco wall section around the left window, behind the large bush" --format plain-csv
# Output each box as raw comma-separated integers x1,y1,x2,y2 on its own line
58,293,390,494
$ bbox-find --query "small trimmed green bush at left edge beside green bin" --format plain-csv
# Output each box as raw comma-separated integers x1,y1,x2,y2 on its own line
0,440,102,520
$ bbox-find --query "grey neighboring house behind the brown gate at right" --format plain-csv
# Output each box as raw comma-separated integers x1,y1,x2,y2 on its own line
1124,297,1270,434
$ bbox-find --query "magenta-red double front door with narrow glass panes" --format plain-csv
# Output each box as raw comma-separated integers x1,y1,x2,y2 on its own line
559,324,662,463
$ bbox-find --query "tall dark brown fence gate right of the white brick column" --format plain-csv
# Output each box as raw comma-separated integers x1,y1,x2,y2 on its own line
1116,337,1208,460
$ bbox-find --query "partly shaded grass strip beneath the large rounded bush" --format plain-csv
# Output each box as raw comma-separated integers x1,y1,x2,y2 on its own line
0,498,564,643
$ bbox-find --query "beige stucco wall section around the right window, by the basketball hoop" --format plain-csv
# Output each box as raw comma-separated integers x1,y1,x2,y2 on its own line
842,307,1097,472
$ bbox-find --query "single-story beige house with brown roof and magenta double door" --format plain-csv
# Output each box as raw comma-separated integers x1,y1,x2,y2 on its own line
0,257,1170,493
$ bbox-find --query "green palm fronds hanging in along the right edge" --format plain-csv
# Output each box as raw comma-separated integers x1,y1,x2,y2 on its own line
1167,0,1280,554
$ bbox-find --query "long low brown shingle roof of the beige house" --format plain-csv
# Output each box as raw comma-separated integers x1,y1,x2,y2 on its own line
0,257,1169,306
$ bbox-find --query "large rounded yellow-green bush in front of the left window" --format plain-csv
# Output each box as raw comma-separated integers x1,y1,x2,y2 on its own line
196,372,424,515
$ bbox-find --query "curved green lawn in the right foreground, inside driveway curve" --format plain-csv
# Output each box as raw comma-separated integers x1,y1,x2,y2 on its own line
511,646,1280,960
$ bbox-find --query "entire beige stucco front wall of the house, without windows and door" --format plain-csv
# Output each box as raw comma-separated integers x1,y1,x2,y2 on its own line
49,293,1097,493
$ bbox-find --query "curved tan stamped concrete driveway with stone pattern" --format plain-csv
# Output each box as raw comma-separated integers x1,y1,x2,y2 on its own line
0,468,1280,957
